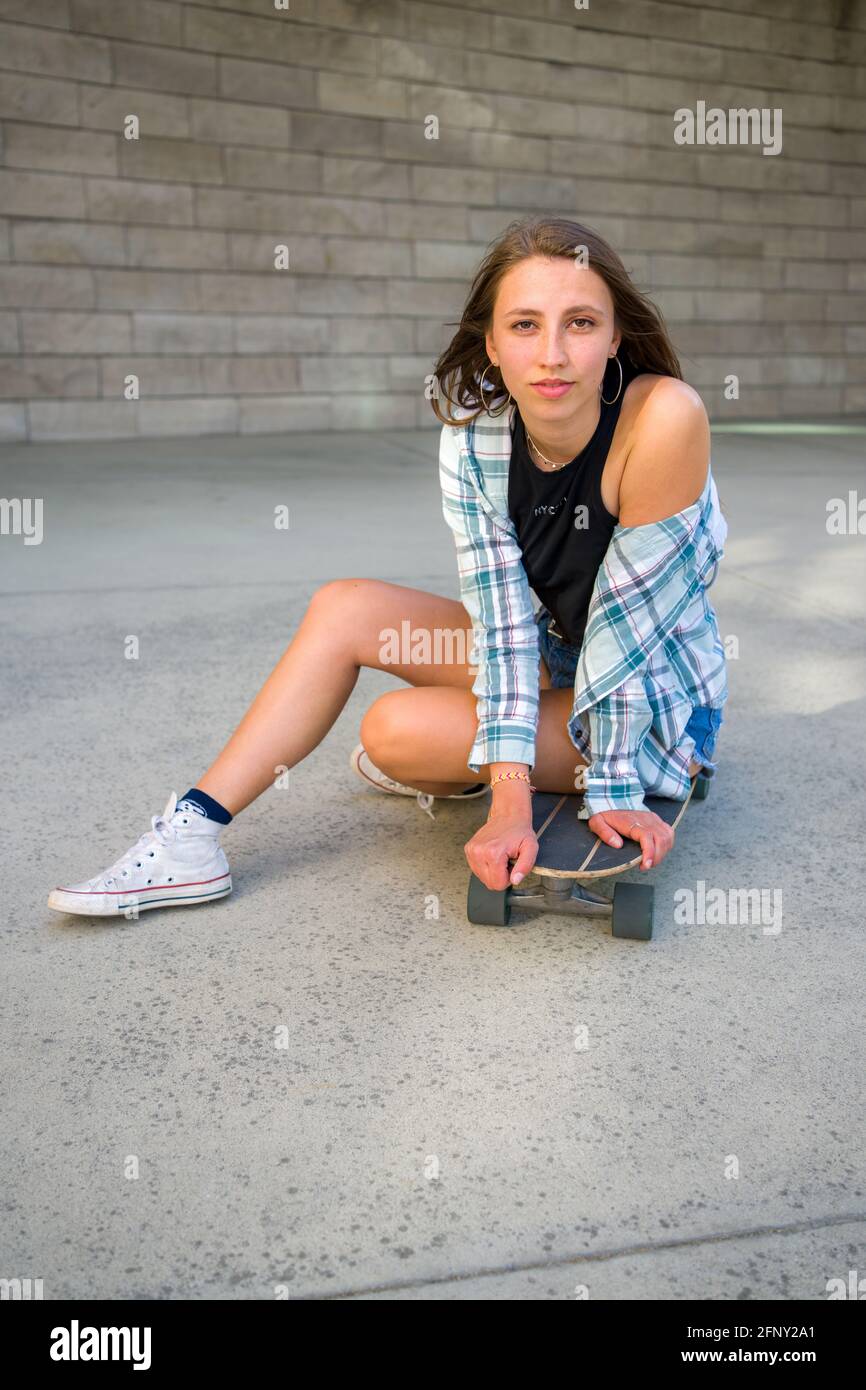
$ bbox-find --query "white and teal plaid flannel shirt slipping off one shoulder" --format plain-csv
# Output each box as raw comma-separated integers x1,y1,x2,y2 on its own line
439,404,727,815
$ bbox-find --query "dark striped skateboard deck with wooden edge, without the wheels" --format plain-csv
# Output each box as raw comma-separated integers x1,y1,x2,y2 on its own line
530,773,701,878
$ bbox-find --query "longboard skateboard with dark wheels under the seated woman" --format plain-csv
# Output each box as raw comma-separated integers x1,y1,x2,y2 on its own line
467,773,710,941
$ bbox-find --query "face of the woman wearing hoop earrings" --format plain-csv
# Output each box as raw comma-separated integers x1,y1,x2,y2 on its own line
484,256,621,417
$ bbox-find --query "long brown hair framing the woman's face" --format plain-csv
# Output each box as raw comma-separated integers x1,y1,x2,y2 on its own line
430,217,683,425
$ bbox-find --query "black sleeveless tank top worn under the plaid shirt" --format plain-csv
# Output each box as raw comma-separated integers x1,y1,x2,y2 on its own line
509,366,637,646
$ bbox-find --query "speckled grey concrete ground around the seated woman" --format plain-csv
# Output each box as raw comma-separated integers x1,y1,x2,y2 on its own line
0,431,866,1300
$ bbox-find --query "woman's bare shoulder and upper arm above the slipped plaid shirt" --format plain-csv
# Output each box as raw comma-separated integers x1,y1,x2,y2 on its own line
620,373,710,525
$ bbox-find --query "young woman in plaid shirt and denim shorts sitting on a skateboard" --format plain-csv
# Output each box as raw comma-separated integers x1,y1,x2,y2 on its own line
49,218,727,916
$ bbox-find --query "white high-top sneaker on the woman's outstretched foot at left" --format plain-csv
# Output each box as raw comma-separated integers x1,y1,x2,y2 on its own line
49,791,232,917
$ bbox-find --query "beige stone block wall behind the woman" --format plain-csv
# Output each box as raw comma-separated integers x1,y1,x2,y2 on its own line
0,0,866,441
